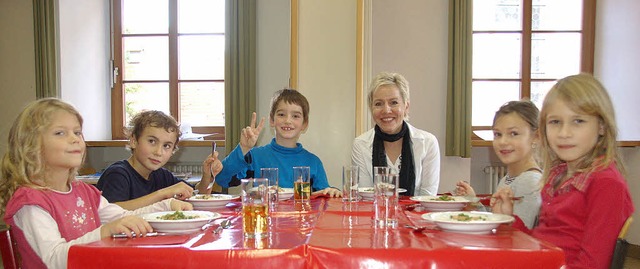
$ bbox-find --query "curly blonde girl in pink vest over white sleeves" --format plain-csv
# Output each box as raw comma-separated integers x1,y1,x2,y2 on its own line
0,98,192,268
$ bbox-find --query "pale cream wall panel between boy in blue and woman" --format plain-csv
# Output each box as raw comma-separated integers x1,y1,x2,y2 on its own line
298,0,356,187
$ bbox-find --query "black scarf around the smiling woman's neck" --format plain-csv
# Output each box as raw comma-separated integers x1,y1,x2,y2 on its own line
372,122,416,196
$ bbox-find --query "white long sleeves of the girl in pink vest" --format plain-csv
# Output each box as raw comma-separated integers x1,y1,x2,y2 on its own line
13,192,171,268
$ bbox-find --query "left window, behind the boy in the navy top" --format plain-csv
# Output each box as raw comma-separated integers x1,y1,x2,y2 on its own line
111,0,225,139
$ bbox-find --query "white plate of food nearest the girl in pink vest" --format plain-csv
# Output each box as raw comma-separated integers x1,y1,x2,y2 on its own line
140,210,221,233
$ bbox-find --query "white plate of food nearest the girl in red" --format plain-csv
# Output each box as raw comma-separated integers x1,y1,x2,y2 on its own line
422,211,515,234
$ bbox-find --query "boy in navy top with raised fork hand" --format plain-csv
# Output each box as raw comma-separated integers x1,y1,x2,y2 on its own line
97,110,222,210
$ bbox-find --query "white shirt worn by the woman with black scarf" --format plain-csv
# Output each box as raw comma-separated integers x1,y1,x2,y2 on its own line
351,123,440,195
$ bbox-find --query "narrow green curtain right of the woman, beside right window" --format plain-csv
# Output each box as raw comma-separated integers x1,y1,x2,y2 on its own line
445,0,473,158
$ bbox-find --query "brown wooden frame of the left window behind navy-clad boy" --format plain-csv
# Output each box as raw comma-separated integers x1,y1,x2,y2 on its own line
111,0,226,141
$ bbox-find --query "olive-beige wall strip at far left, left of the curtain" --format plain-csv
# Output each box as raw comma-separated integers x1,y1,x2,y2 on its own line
0,0,36,155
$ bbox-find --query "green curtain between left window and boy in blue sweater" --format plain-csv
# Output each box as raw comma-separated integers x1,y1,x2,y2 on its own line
224,0,257,154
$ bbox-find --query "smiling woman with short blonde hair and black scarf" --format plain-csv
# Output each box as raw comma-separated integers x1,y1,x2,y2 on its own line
351,72,440,196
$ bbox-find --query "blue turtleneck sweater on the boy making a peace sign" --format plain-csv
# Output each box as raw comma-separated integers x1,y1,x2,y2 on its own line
216,138,329,191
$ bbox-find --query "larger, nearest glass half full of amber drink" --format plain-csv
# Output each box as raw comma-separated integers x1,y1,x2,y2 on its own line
240,178,269,238
